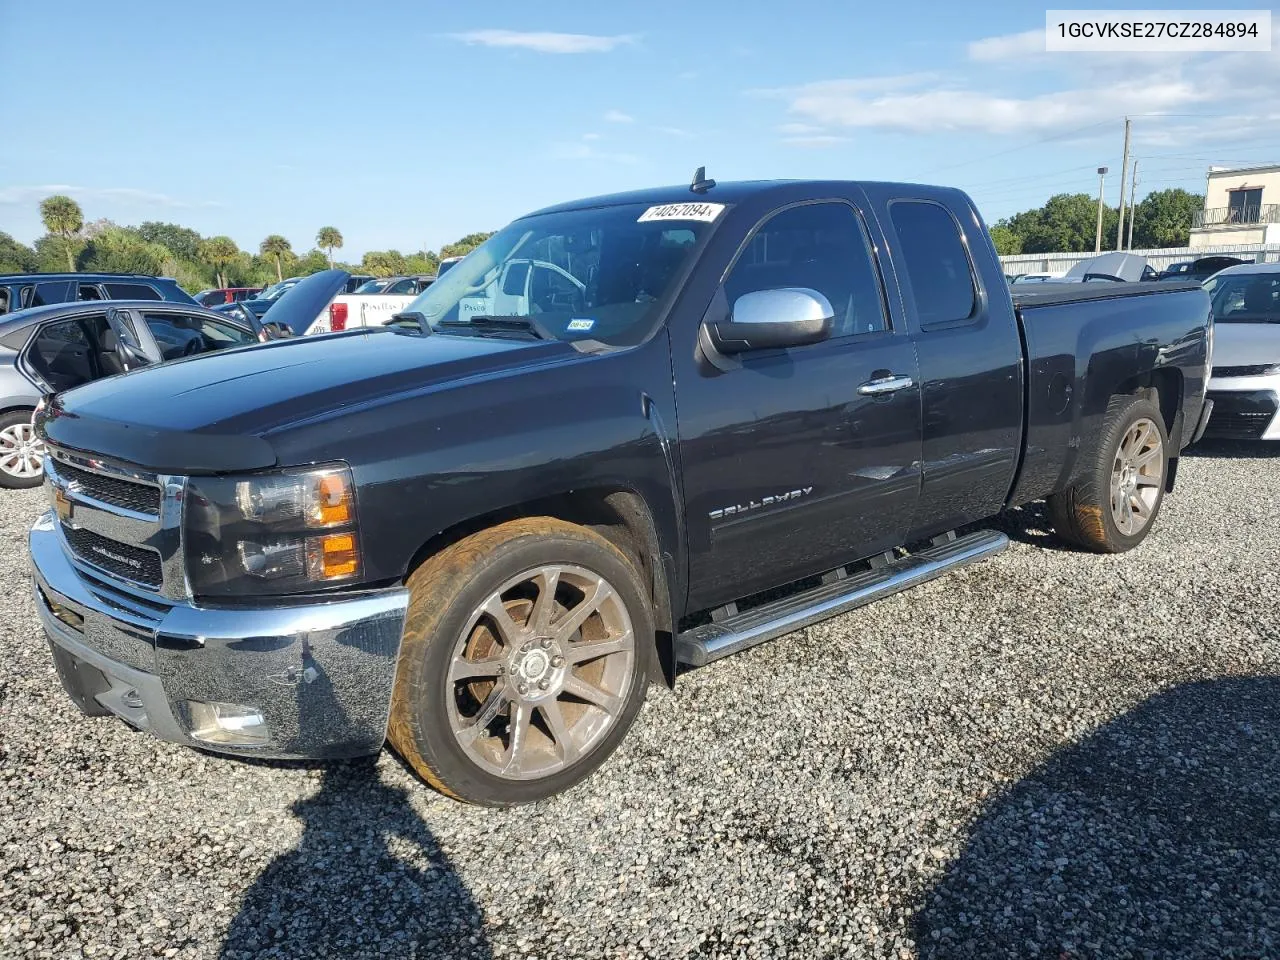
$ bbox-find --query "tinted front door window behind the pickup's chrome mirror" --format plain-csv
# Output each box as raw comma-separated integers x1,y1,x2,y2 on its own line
724,202,888,337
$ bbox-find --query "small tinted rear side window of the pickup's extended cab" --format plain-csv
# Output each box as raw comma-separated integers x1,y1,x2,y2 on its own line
890,200,978,326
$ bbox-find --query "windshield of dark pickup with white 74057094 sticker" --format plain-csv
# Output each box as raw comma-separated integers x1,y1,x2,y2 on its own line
406,204,721,347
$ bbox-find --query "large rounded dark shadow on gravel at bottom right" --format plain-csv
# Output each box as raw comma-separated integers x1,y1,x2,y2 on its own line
914,677,1280,960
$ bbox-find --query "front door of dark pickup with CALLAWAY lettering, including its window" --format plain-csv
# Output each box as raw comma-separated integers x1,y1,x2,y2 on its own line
676,202,920,609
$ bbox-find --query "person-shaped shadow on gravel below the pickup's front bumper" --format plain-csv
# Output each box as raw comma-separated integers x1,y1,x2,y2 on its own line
219,759,492,960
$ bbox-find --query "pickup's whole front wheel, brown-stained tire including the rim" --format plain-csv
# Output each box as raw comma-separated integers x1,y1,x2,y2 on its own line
388,517,655,806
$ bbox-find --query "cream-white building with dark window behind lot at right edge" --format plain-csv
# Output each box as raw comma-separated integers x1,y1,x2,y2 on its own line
1190,164,1280,248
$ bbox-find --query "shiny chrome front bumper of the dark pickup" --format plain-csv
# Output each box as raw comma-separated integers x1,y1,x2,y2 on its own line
29,512,408,759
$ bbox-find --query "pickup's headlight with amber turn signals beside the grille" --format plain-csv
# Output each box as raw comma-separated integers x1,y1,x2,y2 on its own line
183,466,361,596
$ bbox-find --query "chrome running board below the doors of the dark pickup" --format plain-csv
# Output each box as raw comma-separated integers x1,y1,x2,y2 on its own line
676,530,1009,667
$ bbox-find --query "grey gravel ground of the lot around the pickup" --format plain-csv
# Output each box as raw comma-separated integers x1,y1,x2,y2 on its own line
0,447,1280,960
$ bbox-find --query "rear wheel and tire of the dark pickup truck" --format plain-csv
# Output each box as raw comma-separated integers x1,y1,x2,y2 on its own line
1048,396,1169,553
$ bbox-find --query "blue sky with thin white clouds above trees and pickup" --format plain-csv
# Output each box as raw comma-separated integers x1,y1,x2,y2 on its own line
0,0,1280,257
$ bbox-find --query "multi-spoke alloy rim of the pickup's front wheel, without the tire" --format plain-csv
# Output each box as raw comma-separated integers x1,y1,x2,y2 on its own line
448,564,639,780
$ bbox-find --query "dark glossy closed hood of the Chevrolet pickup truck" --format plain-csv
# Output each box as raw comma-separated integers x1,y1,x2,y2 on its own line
38,329,580,474
